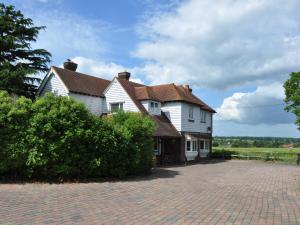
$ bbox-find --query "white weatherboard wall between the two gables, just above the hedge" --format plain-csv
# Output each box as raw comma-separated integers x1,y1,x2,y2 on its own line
69,93,104,115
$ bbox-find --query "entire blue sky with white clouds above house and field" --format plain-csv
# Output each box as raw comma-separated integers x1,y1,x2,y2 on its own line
2,0,300,137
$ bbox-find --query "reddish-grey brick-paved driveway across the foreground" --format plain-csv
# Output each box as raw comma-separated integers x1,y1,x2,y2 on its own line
0,160,300,225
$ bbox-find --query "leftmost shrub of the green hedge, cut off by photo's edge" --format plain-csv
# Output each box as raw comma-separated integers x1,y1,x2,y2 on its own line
0,91,32,175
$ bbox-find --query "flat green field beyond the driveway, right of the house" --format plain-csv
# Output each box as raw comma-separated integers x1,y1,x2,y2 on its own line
213,147,300,163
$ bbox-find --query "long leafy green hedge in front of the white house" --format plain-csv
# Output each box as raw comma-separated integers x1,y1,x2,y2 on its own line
0,92,154,179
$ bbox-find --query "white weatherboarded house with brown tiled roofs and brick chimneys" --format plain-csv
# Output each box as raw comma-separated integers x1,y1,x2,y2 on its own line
38,61,215,163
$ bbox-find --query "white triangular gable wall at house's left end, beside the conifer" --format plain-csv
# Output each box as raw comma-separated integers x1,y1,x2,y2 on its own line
41,73,68,96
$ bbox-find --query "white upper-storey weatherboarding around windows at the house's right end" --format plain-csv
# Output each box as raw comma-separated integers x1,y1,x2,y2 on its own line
180,103,212,133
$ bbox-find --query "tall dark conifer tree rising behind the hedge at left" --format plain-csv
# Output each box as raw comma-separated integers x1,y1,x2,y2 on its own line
0,3,51,98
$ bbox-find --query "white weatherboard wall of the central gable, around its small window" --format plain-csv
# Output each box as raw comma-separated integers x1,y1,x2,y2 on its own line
105,79,140,112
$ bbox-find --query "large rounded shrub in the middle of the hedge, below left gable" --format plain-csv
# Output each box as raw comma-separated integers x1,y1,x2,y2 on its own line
23,94,94,177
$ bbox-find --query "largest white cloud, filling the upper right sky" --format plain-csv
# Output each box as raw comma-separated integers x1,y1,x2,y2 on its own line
132,0,300,89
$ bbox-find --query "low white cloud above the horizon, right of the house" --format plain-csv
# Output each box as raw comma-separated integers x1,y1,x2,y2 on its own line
216,83,295,124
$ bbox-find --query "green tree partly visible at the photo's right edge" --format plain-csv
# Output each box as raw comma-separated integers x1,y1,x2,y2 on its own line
283,72,300,130
